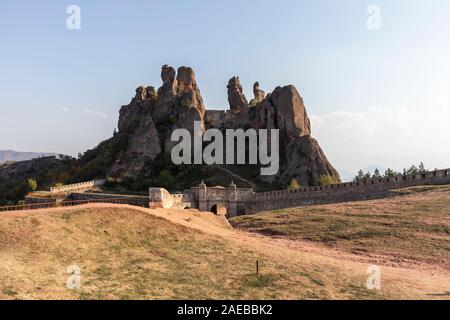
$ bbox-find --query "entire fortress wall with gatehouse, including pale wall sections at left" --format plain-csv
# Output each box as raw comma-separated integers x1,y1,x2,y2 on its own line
25,169,450,217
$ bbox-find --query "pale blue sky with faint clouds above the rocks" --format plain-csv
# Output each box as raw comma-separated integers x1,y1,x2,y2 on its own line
0,0,450,176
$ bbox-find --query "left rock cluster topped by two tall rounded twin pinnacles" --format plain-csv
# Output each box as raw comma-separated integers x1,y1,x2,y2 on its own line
108,65,205,178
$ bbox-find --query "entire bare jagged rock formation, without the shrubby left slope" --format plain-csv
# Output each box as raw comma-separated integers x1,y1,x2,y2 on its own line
84,65,340,187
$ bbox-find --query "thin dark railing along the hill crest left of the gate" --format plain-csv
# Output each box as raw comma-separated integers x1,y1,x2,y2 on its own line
0,198,148,212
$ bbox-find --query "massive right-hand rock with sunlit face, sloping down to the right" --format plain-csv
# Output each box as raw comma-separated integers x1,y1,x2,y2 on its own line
244,83,340,186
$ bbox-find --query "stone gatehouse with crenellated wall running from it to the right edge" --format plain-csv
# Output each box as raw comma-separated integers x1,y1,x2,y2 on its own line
150,169,450,217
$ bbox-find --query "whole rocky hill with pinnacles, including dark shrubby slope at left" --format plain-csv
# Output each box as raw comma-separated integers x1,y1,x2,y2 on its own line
0,65,340,201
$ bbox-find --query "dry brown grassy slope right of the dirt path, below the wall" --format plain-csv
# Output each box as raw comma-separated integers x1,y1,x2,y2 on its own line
232,186,450,272
